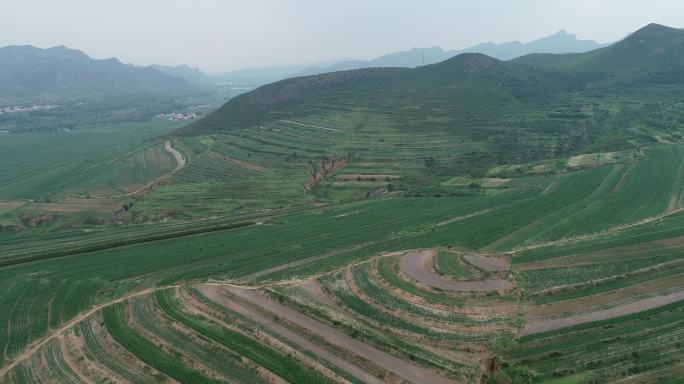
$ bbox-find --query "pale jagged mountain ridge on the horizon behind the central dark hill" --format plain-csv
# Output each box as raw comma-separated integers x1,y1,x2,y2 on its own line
288,31,605,77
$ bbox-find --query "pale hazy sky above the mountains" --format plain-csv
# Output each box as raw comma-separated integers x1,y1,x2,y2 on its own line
0,0,684,72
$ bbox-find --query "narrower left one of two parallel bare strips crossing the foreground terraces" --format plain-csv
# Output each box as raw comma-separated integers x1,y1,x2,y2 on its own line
196,284,382,384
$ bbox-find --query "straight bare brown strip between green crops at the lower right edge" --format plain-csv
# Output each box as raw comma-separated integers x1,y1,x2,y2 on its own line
521,290,684,336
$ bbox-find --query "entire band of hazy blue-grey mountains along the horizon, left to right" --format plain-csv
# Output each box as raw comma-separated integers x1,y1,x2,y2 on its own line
0,31,601,104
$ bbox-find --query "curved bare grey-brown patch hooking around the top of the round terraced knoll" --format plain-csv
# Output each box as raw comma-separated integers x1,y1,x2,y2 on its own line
399,249,513,292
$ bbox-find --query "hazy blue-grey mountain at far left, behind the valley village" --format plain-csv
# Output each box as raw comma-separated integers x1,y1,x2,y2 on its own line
0,46,193,102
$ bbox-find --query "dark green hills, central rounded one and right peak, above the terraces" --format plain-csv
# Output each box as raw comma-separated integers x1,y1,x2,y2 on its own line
180,24,684,165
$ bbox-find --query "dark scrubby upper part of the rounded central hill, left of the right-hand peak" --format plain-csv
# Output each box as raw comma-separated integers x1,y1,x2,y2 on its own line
182,54,584,134
